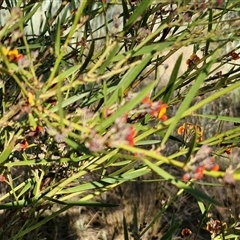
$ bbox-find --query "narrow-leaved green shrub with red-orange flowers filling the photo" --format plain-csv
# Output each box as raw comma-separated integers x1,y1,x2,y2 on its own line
0,0,240,239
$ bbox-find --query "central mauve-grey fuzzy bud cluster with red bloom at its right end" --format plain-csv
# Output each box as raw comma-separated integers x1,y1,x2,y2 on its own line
85,115,136,152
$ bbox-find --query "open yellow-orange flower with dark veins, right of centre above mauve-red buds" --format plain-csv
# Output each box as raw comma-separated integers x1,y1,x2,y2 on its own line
177,123,203,142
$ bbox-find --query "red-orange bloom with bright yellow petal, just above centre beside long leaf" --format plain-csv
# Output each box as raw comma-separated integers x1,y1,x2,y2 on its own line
141,96,167,121
